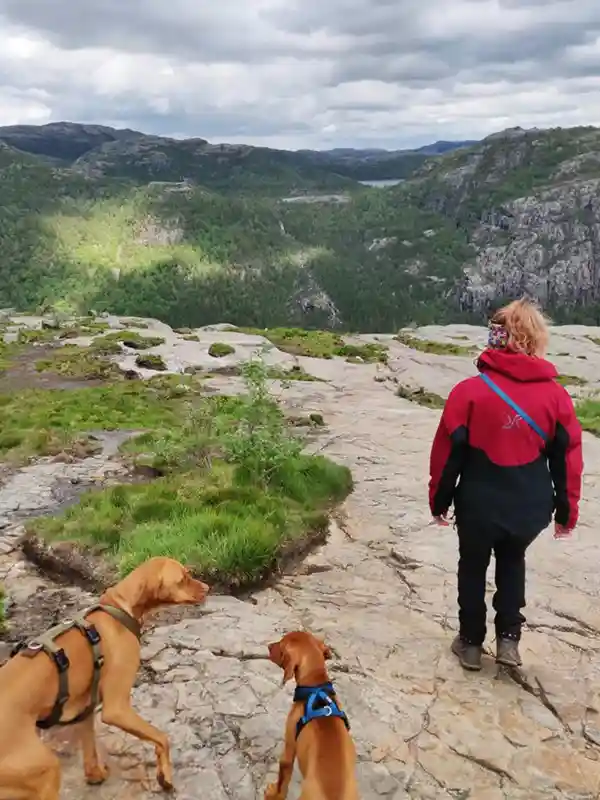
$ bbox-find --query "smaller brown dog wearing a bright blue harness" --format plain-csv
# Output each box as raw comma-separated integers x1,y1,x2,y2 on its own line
265,631,358,800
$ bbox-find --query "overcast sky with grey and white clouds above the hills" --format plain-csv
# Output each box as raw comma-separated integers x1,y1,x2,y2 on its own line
0,0,600,148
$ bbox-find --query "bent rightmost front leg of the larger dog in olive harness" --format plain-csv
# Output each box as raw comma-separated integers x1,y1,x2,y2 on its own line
100,658,173,792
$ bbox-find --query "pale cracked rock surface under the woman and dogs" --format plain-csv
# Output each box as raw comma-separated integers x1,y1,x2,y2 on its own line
0,326,600,800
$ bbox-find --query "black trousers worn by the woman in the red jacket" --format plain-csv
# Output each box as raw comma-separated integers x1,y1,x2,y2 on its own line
458,524,541,645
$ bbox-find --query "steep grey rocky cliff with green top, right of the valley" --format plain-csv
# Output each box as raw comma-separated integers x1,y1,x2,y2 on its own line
410,128,600,321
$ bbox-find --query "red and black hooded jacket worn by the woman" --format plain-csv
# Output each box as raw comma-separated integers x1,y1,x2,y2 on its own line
429,350,583,533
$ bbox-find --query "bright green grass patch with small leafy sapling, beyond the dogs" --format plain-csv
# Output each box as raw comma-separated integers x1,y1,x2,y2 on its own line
26,365,352,587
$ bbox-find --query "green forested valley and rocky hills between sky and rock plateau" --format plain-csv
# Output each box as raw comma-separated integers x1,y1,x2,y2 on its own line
0,123,600,332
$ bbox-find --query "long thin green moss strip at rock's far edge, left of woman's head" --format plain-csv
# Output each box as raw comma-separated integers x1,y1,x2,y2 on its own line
236,328,388,363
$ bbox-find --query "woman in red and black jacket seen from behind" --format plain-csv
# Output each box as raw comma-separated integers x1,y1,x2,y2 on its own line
429,300,583,670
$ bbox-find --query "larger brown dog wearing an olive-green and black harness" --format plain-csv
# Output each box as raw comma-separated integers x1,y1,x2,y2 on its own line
0,558,209,800
